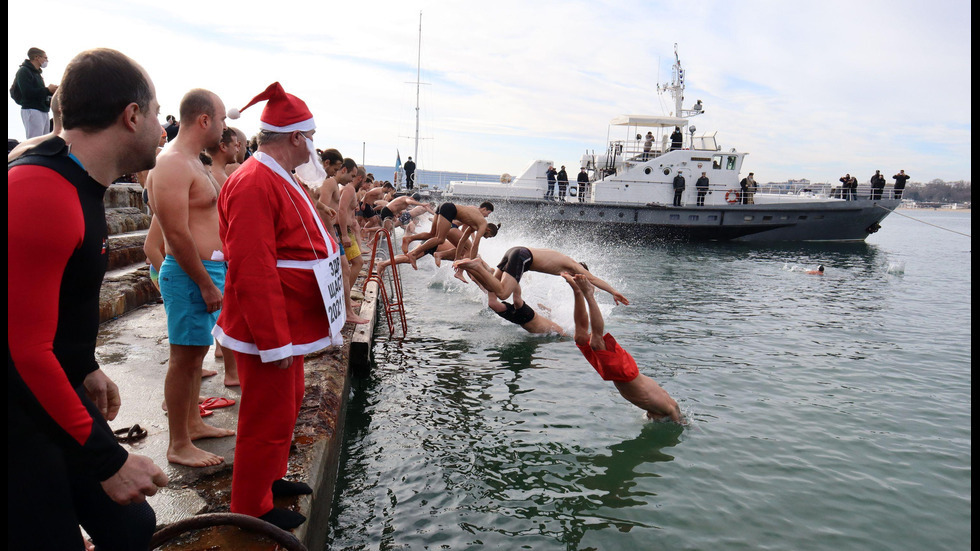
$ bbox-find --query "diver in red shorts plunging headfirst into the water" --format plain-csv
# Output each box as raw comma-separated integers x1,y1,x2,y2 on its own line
564,272,682,423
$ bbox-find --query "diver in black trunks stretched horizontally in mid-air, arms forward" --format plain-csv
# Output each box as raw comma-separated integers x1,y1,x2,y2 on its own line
453,247,630,304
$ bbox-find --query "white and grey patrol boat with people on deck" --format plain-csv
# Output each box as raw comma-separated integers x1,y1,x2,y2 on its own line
442,45,901,241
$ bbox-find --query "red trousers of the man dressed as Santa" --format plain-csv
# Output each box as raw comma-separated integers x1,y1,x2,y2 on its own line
231,352,305,517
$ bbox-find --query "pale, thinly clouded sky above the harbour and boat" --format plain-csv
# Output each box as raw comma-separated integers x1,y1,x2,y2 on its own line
7,0,972,182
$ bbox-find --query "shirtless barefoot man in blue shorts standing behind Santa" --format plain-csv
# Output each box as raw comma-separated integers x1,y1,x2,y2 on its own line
147,89,235,467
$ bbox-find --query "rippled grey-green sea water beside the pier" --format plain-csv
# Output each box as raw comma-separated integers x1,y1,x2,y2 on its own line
329,211,972,550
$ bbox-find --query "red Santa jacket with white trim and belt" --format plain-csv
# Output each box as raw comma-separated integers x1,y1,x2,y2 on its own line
212,153,337,362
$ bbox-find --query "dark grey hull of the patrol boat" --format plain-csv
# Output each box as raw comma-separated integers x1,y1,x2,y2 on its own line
444,197,901,242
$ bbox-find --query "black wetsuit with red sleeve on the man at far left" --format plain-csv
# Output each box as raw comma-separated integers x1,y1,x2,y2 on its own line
7,138,156,549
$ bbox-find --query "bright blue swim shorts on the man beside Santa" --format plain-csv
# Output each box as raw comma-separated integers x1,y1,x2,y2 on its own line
160,254,227,346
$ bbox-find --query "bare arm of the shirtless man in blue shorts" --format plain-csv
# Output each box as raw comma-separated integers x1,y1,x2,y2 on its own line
147,162,221,312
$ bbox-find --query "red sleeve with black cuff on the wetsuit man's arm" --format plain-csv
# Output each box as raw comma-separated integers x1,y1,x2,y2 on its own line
7,167,127,480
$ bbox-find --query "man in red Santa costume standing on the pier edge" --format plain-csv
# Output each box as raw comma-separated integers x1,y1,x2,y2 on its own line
213,82,345,530
